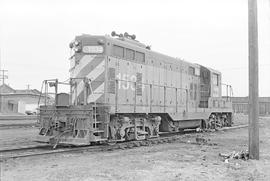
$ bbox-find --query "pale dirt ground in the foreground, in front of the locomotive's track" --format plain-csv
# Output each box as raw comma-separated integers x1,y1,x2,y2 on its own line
1,115,270,181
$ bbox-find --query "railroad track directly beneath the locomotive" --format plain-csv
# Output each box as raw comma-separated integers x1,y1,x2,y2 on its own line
0,125,247,161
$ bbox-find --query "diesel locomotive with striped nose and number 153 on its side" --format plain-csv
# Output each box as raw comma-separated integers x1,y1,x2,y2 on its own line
38,32,232,145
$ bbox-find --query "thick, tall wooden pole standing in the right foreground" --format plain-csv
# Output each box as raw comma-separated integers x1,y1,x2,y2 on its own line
248,0,259,160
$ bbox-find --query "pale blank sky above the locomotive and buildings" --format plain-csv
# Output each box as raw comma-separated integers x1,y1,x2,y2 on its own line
0,0,270,96
